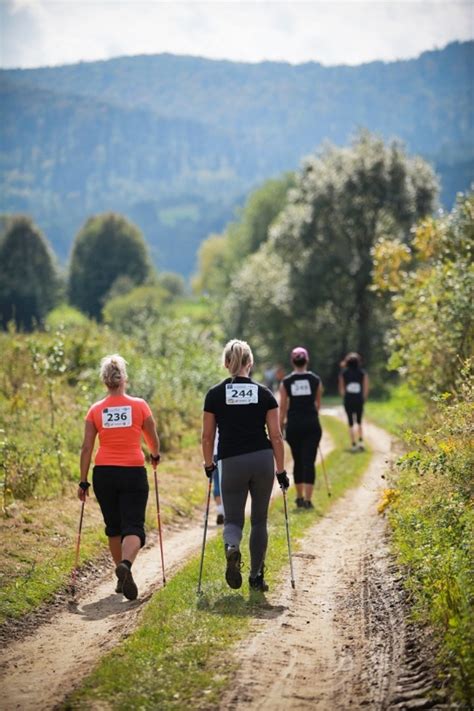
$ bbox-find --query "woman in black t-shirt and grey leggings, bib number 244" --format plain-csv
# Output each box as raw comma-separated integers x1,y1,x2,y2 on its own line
202,339,289,592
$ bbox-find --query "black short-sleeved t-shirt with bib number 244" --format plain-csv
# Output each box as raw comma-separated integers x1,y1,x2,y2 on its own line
204,376,278,459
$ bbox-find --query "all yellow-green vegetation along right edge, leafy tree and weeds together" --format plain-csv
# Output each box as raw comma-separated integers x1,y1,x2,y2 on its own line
368,196,474,706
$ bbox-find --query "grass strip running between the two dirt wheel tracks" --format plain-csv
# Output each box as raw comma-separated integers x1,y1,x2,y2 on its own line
64,417,370,710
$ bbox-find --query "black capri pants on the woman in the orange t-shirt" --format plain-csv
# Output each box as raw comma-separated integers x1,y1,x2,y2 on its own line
92,466,149,546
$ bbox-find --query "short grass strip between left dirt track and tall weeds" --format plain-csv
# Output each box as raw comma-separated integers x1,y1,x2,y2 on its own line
0,445,207,623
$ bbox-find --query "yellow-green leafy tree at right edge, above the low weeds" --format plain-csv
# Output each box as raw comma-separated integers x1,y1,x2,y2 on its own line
375,195,474,395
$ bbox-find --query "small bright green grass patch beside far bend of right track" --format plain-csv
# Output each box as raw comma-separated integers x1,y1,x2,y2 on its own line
365,384,426,437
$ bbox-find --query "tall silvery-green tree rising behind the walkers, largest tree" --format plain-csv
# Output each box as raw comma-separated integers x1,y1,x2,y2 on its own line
228,132,437,378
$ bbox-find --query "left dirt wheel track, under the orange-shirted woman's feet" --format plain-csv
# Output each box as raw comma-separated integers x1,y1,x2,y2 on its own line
0,437,331,711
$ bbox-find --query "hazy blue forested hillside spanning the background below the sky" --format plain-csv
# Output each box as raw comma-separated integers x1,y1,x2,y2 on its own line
0,42,474,274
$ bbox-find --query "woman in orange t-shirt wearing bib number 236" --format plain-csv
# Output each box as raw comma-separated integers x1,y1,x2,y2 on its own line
78,354,160,600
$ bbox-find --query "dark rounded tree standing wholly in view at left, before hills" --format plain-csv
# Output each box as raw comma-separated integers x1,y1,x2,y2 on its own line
69,213,151,319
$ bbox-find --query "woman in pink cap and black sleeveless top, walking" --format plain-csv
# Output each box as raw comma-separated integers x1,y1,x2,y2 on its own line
280,346,322,509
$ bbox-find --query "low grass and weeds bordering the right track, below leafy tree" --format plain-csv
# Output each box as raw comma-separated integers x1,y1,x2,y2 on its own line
367,386,474,708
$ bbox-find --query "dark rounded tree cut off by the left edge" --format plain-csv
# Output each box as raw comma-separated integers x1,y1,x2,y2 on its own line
0,216,59,330
